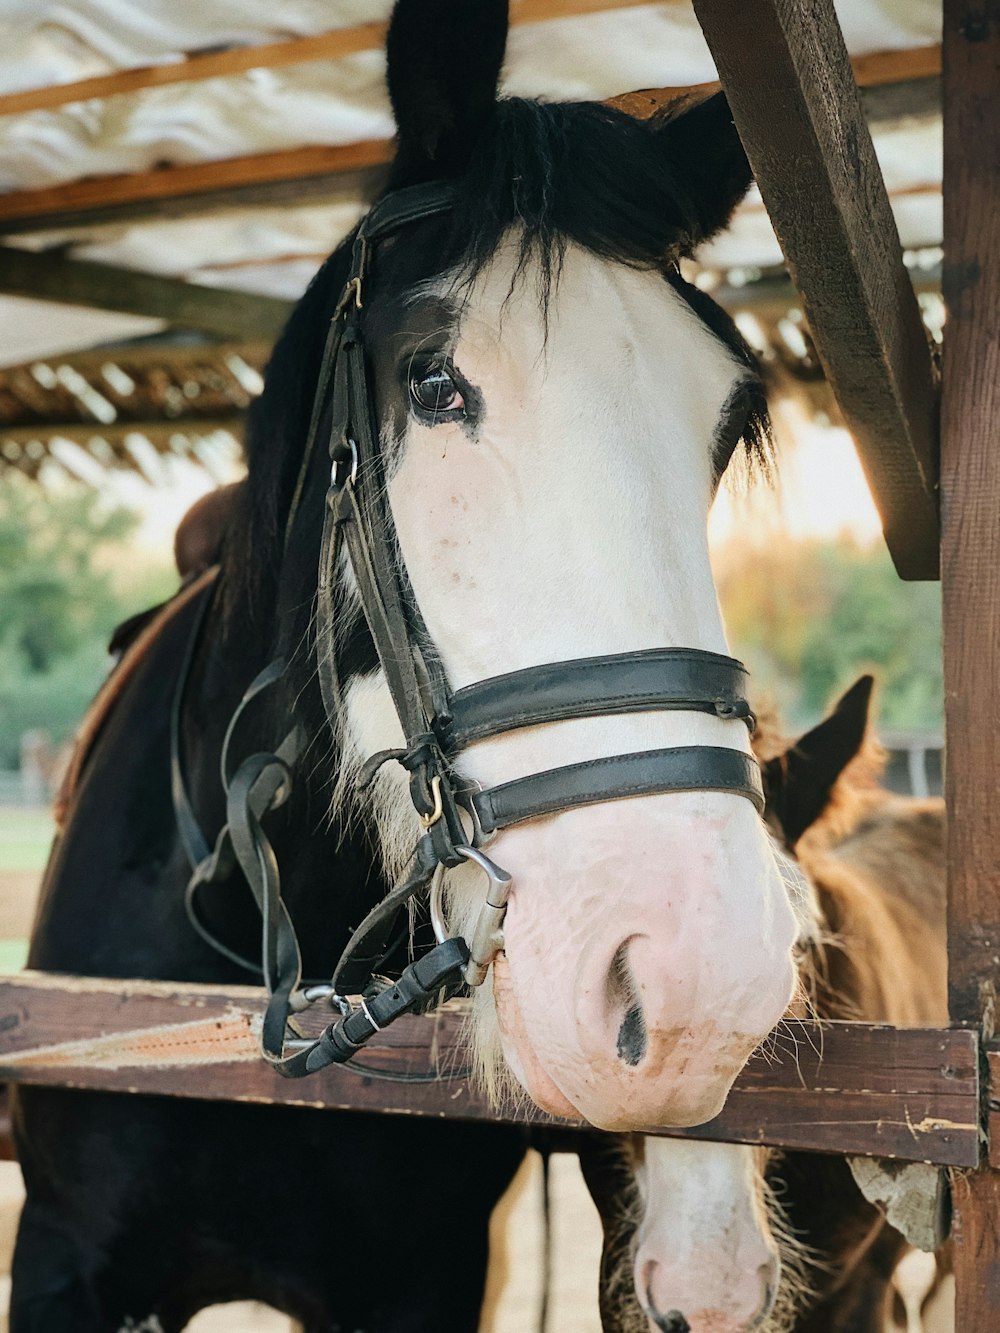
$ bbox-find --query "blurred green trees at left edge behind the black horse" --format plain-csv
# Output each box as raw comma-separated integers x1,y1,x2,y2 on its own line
0,471,177,768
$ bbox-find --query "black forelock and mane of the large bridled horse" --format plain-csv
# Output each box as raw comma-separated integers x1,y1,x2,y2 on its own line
231,95,769,629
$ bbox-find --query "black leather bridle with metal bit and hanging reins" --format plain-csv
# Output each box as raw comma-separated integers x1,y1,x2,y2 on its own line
173,184,764,1077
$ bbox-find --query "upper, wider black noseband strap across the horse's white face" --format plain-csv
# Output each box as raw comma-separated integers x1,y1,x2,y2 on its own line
445,648,755,750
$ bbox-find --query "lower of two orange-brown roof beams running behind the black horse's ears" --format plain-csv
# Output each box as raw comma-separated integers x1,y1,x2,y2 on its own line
0,47,940,235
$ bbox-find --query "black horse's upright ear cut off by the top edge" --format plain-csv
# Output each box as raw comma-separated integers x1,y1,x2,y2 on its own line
385,0,508,185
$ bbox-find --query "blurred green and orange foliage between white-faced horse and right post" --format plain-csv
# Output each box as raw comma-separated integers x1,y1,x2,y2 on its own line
717,536,943,730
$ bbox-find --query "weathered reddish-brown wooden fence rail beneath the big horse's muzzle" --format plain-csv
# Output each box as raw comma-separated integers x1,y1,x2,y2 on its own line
0,973,979,1165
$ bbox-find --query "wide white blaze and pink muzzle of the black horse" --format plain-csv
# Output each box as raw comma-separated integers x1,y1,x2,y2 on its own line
347,237,797,1129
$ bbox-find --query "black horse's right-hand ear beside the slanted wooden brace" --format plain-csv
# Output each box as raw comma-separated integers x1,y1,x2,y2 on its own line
659,92,753,249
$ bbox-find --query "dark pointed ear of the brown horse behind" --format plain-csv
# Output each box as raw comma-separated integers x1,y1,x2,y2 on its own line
763,676,875,848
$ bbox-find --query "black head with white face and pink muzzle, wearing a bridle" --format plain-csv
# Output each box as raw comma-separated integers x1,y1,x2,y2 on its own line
256,0,797,1129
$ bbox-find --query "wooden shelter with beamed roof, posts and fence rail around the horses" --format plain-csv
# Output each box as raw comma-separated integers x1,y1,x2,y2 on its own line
0,0,1000,1333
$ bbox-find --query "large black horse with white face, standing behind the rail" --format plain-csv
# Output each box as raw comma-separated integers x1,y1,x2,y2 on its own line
12,0,797,1333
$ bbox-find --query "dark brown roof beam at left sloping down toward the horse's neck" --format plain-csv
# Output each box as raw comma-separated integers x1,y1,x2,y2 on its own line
0,245,295,340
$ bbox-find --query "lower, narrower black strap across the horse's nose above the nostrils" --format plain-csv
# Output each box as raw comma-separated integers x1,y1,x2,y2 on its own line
472,745,764,833
